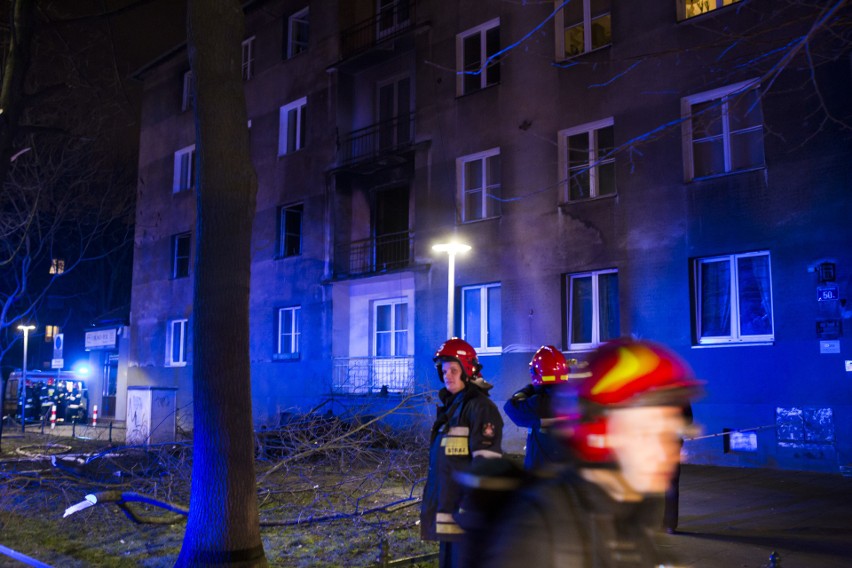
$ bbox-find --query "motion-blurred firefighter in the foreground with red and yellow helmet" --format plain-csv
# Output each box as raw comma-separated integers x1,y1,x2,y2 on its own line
482,340,700,568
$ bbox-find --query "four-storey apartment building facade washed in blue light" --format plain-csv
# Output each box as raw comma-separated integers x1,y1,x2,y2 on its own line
128,0,852,471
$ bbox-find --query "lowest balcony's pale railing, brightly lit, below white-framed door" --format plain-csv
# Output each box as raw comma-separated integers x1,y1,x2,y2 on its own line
331,357,414,395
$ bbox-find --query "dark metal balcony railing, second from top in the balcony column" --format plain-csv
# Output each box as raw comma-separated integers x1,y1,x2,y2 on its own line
337,113,414,166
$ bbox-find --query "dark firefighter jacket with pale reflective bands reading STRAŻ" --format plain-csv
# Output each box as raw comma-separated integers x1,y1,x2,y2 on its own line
420,383,503,541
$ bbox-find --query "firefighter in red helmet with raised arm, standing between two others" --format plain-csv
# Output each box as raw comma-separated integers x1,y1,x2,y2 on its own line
503,345,580,470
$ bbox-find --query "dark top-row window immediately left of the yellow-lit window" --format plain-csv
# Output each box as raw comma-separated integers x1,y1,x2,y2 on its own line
456,18,500,96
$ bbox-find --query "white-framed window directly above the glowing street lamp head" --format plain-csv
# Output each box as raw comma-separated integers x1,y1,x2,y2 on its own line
456,148,500,223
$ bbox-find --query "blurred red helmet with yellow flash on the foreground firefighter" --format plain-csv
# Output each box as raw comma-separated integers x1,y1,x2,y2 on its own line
569,339,701,464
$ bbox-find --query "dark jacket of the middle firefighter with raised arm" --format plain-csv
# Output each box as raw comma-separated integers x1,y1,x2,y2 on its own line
503,384,567,470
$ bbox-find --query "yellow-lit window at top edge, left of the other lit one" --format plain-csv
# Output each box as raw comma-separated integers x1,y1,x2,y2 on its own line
554,0,612,59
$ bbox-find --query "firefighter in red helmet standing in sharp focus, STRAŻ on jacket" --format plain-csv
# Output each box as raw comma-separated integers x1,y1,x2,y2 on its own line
420,338,503,568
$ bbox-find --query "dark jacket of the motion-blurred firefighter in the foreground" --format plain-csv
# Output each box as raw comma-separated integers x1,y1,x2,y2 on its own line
482,470,673,568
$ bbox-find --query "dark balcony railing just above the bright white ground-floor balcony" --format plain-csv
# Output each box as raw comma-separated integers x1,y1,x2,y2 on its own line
335,231,414,276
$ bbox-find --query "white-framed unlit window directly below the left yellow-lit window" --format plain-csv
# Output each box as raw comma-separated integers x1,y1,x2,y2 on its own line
559,118,615,201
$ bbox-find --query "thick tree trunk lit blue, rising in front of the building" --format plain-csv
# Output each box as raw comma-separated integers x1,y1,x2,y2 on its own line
177,0,267,566
